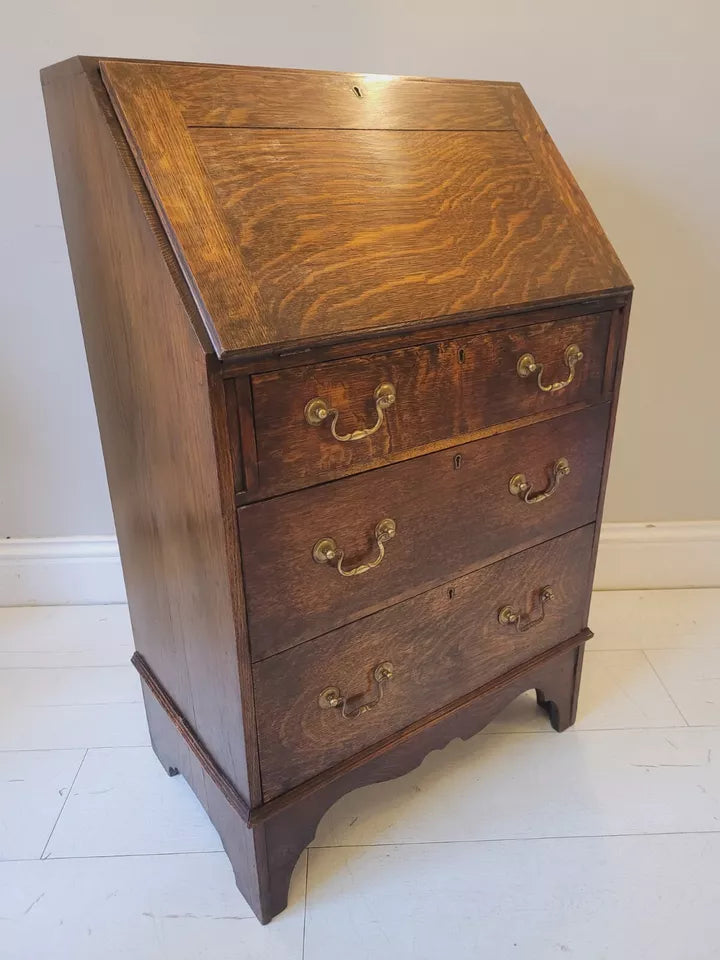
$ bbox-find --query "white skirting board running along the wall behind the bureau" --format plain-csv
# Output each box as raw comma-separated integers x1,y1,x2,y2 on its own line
0,520,720,607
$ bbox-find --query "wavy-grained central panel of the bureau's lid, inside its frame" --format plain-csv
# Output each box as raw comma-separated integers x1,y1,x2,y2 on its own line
198,129,612,339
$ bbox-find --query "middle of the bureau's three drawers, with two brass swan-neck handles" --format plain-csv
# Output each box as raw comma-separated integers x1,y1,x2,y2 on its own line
238,404,609,660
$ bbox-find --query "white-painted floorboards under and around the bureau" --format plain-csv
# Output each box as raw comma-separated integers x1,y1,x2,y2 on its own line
0,590,720,960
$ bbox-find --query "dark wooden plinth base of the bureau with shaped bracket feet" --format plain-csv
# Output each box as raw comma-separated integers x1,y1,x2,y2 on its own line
138,630,592,923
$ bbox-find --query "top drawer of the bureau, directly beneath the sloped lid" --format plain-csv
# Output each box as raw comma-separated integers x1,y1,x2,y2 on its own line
252,313,611,493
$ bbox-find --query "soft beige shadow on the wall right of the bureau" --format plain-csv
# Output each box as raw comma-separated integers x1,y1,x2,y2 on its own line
575,165,720,521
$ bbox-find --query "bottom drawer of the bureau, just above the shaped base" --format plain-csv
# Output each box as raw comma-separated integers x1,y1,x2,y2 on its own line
253,524,594,800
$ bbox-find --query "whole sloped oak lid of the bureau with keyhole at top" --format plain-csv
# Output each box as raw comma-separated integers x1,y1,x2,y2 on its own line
100,60,630,357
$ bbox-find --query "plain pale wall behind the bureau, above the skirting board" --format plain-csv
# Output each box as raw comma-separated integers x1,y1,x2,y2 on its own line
0,0,720,537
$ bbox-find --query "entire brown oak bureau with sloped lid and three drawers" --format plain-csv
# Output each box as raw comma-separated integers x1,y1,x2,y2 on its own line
42,57,632,922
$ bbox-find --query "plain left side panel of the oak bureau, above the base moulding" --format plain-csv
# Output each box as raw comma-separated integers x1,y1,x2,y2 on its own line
43,59,256,803
